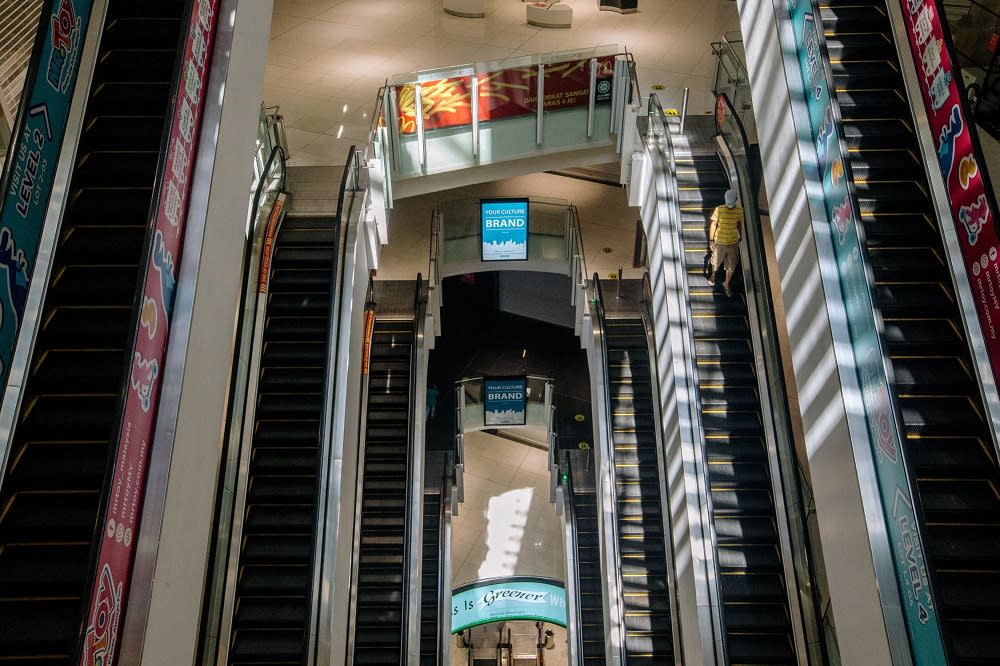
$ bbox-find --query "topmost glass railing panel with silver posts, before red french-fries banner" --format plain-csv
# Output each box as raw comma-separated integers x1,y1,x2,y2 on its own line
373,46,631,178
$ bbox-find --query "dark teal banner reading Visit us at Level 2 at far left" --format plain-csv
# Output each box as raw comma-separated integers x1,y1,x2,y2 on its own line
0,0,93,386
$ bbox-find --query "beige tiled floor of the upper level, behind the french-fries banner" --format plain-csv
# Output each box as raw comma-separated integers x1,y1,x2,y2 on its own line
264,0,739,165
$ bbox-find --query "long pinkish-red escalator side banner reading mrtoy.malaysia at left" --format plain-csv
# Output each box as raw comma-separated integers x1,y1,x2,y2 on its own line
80,0,219,666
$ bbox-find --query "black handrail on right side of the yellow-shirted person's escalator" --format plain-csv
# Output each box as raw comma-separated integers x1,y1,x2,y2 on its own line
718,93,827,659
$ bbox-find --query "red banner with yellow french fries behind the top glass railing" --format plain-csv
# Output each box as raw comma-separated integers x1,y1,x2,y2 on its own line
395,55,615,134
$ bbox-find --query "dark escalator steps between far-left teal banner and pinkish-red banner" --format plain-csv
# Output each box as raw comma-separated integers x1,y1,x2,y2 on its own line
0,0,189,664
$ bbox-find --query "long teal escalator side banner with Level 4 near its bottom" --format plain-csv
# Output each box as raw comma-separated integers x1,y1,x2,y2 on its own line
788,0,947,665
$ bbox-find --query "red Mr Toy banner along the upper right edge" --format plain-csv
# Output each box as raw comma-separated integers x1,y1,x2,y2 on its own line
900,0,1000,384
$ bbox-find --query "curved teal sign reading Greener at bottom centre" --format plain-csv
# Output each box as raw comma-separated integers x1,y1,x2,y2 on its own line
451,576,566,634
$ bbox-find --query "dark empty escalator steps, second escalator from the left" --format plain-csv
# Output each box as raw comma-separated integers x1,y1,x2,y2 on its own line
229,217,337,665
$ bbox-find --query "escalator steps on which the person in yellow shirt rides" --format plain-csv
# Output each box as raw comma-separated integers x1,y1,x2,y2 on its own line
674,123,796,664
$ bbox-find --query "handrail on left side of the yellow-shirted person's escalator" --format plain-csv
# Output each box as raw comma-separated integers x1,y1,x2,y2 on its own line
645,93,728,662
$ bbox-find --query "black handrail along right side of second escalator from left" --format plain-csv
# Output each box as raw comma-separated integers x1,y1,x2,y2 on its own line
306,145,360,664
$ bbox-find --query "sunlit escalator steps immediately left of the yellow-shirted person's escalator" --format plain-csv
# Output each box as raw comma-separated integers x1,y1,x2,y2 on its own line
603,317,674,666
